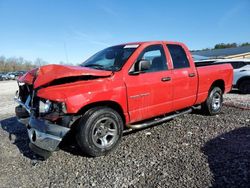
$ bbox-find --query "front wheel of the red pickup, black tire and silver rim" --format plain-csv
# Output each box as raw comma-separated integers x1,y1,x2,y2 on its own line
76,107,123,157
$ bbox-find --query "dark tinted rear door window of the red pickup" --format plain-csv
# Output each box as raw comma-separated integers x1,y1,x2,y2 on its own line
167,44,190,69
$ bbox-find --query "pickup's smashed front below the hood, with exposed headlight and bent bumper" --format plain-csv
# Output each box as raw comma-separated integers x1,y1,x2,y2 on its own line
15,71,72,156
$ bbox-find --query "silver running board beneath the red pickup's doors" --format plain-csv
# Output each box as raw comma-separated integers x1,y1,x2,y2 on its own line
124,108,192,132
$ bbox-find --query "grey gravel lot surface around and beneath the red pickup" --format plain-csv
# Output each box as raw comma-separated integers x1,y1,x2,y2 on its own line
0,81,250,187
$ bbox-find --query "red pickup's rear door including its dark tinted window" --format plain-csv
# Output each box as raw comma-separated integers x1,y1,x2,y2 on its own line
167,44,198,110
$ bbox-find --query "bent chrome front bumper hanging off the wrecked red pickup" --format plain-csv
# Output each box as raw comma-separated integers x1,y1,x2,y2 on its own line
15,98,70,152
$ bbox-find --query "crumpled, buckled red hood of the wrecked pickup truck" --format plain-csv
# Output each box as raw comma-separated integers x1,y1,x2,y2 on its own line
18,64,112,88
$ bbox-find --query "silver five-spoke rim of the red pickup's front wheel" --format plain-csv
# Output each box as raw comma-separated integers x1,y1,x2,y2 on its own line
92,117,118,148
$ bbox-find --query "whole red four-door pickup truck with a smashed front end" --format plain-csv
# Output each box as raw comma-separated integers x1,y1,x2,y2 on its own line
15,41,233,156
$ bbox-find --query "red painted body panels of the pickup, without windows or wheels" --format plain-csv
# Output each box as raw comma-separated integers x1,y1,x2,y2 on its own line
19,41,233,124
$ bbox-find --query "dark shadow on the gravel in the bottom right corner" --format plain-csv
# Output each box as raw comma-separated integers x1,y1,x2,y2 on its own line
202,127,250,187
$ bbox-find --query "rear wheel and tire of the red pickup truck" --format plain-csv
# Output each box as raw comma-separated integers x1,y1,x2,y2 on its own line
201,87,223,116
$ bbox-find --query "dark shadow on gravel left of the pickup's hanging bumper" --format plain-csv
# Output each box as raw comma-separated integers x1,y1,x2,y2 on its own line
0,117,43,160
